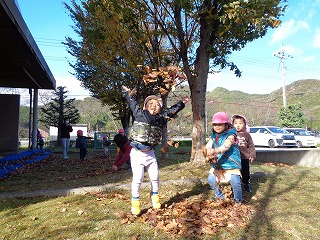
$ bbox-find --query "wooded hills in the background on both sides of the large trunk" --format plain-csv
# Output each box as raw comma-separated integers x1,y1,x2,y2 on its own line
20,79,320,137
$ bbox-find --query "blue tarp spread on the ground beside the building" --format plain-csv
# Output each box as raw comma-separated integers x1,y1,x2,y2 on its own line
0,149,52,179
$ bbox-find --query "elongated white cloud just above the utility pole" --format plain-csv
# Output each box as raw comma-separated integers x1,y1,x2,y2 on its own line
271,19,309,44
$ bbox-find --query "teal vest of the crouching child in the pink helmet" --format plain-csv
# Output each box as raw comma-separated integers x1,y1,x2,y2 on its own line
211,128,241,170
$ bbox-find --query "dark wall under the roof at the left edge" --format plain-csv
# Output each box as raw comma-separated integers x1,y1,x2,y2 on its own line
0,94,20,152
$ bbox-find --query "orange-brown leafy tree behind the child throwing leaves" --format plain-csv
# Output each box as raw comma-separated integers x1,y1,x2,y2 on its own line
65,0,182,133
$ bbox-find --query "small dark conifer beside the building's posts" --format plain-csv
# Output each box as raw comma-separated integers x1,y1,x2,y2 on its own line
39,86,80,145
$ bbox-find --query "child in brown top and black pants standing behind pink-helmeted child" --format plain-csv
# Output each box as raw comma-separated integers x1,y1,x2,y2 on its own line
232,114,256,192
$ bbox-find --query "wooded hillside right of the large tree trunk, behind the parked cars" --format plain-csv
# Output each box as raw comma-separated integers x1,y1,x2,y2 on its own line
207,79,320,129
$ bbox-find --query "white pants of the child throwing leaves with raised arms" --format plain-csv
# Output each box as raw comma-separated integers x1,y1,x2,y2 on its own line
130,148,159,198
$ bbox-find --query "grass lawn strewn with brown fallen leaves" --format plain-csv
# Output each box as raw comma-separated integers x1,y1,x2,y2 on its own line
0,147,320,239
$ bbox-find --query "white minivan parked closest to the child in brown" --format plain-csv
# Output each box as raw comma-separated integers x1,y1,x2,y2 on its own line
250,126,297,148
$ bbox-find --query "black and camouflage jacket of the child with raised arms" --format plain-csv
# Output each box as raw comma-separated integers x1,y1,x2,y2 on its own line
124,92,185,146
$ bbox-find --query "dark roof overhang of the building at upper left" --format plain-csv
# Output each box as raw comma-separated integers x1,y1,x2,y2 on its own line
0,0,56,89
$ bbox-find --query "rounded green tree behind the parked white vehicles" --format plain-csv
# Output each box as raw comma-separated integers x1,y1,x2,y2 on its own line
278,104,307,128
